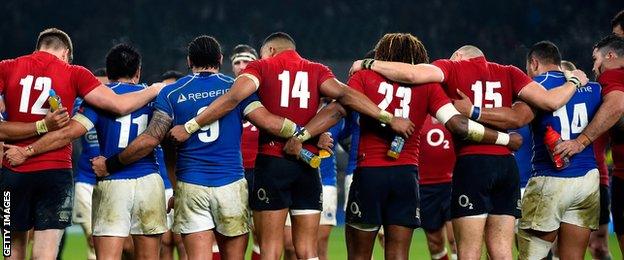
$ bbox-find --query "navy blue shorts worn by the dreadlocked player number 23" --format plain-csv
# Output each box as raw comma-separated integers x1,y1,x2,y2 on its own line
346,165,420,228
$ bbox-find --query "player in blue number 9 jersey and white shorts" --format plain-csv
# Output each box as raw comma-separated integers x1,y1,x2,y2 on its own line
93,35,339,259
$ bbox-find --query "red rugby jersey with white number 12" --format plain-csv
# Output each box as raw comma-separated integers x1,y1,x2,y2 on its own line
0,51,101,173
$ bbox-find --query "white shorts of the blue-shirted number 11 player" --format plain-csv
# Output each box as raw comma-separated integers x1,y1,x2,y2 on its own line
93,173,167,237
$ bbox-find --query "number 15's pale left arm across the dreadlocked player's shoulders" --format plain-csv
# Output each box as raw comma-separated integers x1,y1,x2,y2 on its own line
349,59,444,84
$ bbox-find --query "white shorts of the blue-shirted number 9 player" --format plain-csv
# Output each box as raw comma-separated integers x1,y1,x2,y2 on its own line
172,178,250,237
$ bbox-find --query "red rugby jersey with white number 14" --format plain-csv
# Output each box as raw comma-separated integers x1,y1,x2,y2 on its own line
241,50,334,157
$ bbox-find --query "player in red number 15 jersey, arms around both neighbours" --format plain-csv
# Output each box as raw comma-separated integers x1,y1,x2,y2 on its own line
351,45,587,259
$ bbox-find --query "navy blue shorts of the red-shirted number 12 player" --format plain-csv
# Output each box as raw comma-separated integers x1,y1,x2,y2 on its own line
0,168,74,231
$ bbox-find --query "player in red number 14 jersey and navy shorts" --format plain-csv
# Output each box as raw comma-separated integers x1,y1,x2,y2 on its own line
170,32,414,259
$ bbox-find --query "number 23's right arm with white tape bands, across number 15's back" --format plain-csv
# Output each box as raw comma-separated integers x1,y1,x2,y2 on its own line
435,103,522,151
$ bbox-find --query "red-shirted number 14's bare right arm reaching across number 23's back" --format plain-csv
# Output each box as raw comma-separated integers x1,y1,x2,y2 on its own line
320,78,414,137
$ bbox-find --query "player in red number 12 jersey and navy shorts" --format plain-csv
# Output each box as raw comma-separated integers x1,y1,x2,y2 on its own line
0,28,162,259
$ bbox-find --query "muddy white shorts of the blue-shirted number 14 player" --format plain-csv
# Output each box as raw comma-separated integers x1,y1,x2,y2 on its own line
519,169,600,232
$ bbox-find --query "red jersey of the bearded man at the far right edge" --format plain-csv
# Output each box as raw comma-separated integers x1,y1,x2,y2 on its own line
598,69,624,179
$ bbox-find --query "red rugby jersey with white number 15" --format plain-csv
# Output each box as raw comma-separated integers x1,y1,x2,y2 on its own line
433,57,533,155
